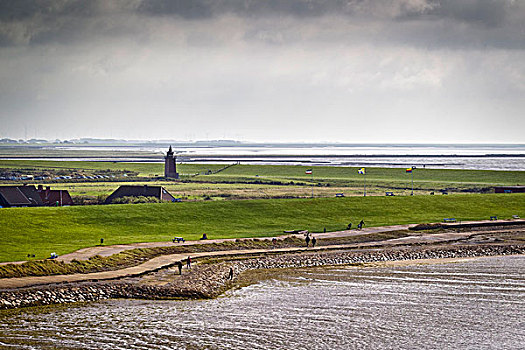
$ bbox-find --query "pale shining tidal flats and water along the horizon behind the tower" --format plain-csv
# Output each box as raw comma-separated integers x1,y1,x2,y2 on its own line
4,144,525,171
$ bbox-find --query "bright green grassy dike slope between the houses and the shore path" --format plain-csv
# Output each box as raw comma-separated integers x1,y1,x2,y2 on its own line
0,194,525,261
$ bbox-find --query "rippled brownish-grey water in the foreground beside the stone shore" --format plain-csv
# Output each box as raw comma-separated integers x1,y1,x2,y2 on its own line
0,256,525,349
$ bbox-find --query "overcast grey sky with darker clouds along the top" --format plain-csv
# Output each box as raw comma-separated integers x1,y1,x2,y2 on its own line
0,0,525,143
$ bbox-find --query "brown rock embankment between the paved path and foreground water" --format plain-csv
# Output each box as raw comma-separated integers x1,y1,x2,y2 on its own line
0,245,525,309
